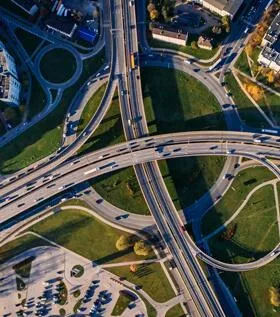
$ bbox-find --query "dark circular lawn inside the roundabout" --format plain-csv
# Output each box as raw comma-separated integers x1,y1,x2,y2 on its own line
40,48,77,83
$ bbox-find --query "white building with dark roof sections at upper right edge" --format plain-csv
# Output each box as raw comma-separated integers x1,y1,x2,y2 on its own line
258,12,280,72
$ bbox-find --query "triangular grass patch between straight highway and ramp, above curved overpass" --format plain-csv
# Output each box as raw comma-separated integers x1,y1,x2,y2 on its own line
78,88,125,154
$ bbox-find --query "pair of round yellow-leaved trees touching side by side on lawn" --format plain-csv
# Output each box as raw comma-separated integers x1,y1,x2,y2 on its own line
116,235,151,256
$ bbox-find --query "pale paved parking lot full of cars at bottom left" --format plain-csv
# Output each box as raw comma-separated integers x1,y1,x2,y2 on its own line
0,247,145,317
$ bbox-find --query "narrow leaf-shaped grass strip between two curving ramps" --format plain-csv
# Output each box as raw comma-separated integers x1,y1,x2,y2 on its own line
77,84,107,134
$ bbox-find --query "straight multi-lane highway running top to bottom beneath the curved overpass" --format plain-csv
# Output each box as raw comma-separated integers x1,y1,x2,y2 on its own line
118,1,223,316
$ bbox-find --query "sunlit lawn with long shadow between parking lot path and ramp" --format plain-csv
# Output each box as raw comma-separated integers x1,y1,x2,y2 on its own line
30,209,153,264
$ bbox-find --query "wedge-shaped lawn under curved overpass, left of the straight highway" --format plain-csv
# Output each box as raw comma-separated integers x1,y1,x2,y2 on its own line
91,167,149,215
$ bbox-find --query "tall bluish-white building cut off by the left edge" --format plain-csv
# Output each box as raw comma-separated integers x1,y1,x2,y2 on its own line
0,42,21,106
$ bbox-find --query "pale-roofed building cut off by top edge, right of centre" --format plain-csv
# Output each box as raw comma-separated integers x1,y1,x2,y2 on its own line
191,0,244,19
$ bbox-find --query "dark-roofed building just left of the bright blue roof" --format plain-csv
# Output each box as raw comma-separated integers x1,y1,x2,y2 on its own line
46,16,78,38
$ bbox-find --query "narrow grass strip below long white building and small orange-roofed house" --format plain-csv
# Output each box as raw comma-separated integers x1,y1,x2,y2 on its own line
149,39,219,60
